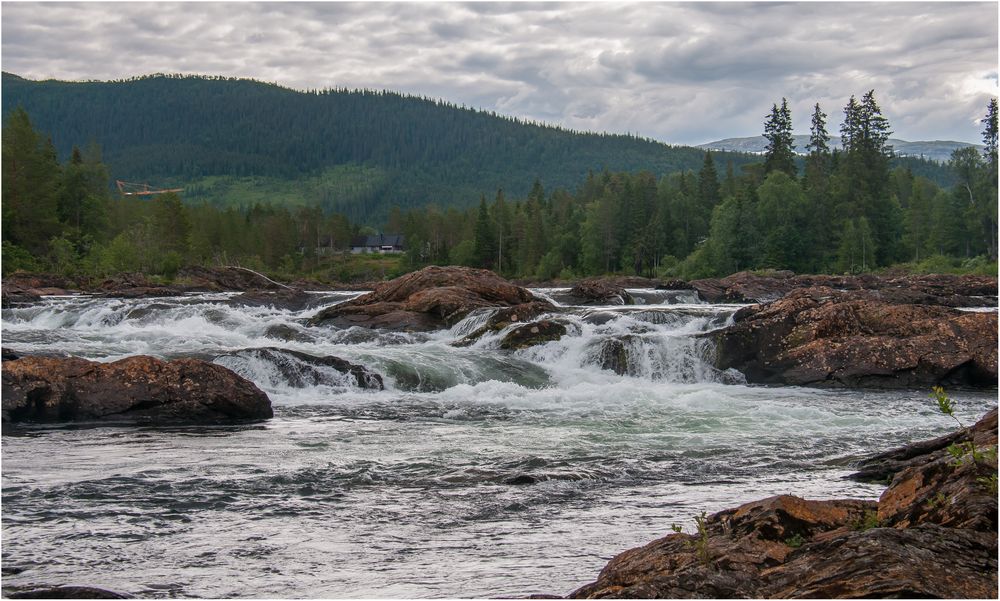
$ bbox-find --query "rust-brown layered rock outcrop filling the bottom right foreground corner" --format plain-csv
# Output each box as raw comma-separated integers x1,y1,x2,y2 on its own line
570,413,997,599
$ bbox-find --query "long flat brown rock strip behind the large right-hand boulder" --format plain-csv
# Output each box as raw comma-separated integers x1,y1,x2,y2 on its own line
688,271,997,307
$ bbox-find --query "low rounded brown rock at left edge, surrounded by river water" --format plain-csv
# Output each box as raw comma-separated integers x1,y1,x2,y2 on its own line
2,356,273,422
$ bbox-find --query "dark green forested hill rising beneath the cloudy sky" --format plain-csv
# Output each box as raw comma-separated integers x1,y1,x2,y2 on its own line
3,73,760,223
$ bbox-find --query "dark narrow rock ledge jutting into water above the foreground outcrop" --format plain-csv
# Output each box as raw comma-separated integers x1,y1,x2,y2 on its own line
849,409,997,482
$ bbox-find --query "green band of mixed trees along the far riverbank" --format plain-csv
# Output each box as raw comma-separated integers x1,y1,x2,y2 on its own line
3,91,997,279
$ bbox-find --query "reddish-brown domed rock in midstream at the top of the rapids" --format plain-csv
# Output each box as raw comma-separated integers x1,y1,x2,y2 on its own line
309,266,544,331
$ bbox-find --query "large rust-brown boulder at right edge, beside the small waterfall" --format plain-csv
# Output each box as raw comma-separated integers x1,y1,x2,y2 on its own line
710,287,997,388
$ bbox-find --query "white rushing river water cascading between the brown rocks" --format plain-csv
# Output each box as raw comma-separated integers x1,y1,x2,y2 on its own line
2,289,995,598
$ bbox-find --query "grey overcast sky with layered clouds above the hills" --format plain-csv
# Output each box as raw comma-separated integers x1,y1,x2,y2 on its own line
0,2,998,144
